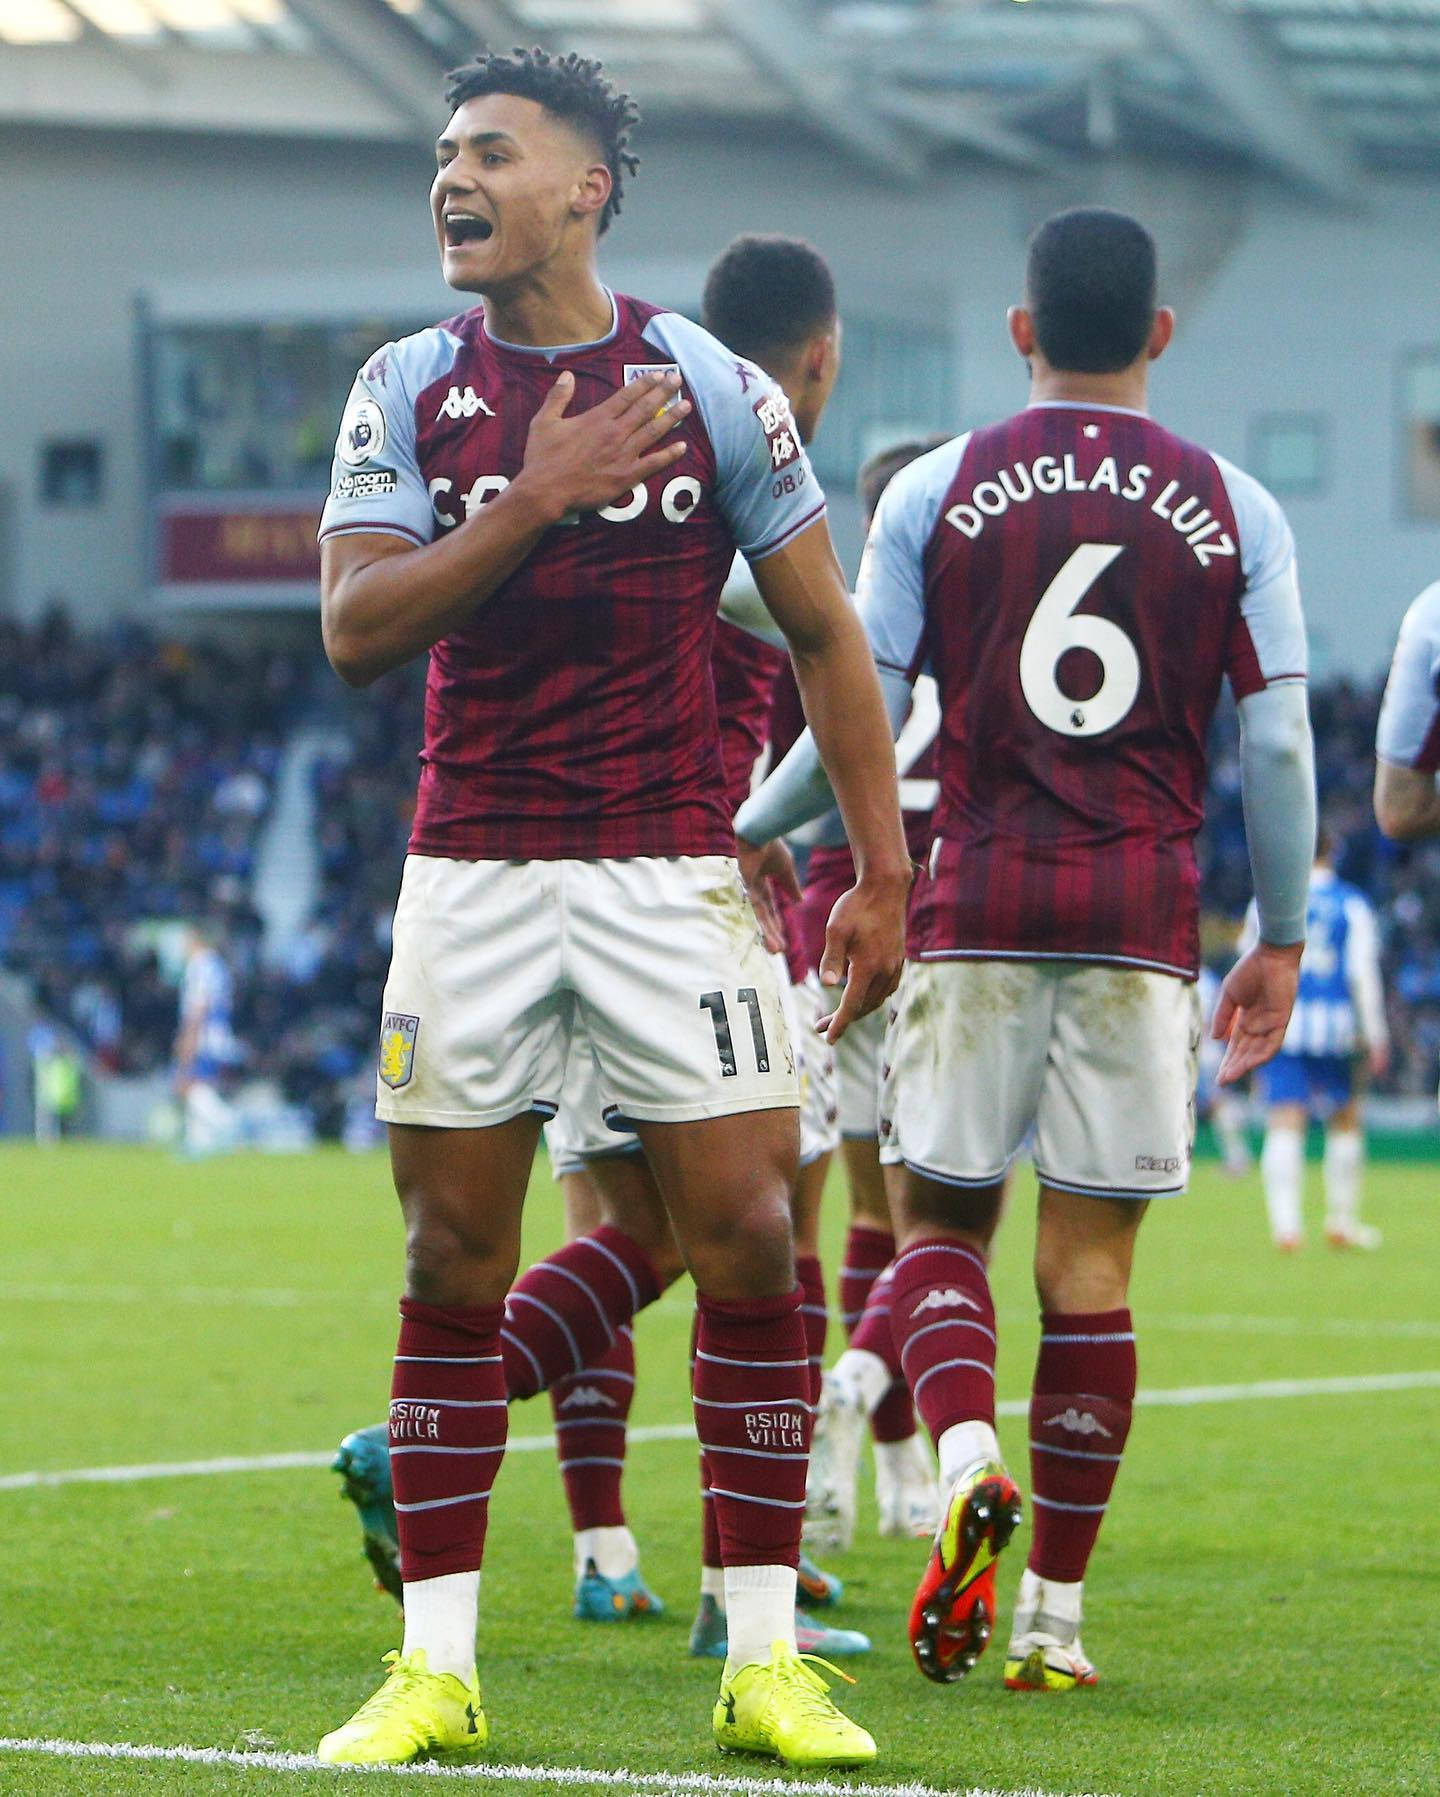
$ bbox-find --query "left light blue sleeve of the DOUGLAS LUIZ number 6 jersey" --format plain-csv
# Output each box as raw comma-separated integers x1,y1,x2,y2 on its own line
856,431,971,679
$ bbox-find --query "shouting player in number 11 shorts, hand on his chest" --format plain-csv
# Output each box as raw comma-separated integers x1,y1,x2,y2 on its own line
311,50,910,1765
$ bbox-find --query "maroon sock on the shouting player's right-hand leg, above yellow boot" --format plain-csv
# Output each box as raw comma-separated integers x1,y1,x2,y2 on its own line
696,1287,811,1567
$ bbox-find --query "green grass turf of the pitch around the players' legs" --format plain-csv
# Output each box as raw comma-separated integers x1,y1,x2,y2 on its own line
0,1146,1440,1797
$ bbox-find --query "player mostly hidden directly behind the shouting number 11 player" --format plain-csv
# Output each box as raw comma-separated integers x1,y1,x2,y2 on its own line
334,235,870,1659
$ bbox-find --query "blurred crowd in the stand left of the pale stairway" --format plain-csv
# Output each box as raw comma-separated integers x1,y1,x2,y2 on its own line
0,609,307,1073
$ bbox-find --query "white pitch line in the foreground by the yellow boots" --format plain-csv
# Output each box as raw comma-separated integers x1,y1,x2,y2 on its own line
0,1736,1100,1797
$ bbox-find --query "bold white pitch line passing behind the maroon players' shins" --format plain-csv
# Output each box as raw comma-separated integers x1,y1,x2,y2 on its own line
0,1371,1440,1495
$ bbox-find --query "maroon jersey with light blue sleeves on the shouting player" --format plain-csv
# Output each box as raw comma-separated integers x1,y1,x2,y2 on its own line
320,295,825,859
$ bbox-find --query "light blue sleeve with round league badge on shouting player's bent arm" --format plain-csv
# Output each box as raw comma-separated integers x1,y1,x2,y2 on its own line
320,331,458,544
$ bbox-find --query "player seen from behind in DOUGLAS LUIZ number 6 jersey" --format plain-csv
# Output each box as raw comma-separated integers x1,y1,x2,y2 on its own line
737,208,1314,1689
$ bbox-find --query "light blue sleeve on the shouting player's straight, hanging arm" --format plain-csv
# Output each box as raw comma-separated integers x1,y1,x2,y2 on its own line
645,313,825,562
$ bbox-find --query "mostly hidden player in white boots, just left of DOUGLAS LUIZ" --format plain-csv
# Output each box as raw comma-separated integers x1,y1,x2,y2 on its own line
786,437,944,1553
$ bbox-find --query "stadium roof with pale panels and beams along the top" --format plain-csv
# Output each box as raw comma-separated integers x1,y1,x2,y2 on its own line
0,0,1440,203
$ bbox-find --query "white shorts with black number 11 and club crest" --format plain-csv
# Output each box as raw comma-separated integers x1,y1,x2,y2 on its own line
376,855,800,1129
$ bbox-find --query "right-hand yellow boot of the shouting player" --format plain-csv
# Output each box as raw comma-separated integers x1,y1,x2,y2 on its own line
714,1641,876,1766
